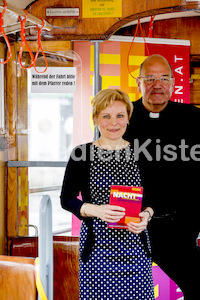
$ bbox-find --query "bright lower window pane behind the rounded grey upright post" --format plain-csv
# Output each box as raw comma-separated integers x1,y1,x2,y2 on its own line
29,167,71,235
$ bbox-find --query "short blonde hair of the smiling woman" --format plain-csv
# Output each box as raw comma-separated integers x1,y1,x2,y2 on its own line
92,89,133,124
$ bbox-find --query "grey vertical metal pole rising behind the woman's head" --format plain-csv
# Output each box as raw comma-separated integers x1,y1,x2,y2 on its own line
93,42,102,140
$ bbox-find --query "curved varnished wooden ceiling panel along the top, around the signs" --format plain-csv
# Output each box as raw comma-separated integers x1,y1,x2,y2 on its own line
28,0,200,40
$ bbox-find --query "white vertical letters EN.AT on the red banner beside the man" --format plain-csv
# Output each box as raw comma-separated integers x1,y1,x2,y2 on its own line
174,55,184,103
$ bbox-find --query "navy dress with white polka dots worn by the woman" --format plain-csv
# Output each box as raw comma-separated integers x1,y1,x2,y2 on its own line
79,146,154,300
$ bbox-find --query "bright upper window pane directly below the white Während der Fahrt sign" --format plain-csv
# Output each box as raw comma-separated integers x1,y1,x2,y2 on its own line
28,94,73,161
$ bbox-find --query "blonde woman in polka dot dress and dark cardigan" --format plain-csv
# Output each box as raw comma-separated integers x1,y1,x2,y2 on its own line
61,89,154,300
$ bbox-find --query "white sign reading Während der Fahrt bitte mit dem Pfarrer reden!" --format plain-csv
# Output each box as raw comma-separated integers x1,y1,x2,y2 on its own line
31,67,76,93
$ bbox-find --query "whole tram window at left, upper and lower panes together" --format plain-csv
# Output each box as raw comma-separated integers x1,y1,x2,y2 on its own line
28,73,73,235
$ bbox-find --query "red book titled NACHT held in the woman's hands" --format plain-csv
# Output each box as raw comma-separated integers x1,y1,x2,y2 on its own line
108,185,143,229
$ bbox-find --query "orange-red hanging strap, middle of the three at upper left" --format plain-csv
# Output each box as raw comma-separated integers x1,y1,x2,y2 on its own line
18,10,34,70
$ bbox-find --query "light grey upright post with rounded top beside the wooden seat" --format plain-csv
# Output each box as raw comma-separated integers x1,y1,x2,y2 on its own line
38,195,53,300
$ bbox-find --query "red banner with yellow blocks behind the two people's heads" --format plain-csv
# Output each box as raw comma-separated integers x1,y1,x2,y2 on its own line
74,36,190,145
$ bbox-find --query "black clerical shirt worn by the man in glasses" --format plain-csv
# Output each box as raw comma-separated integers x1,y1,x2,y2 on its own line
124,99,200,232
